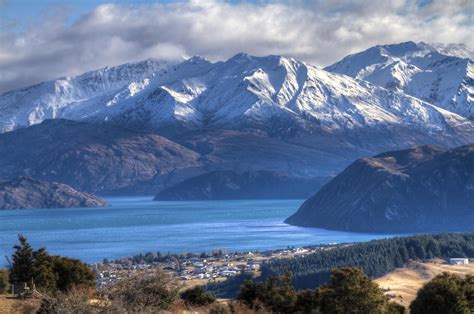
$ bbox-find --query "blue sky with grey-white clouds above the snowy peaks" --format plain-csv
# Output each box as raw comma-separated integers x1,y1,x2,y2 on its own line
0,0,474,93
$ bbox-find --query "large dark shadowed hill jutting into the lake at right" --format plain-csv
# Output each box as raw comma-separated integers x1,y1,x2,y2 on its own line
286,145,474,232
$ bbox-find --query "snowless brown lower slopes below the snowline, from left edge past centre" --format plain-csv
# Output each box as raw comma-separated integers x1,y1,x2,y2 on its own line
0,119,356,195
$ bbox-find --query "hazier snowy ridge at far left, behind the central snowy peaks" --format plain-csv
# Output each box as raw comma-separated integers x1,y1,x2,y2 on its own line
0,59,168,132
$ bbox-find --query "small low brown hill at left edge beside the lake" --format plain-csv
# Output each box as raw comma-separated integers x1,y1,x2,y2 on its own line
0,177,107,209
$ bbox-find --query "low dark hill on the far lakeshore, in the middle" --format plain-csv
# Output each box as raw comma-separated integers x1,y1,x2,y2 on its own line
155,171,328,201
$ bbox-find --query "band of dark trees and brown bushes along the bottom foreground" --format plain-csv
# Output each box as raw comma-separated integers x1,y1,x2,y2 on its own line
0,235,474,314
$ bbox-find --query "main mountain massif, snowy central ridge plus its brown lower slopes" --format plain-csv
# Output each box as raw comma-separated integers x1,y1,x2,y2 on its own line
0,43,474,195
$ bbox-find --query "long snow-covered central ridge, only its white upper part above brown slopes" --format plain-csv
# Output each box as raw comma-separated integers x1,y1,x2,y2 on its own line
0,49,474,144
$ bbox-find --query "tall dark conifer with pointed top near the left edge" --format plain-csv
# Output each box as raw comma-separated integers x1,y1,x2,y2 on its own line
10,234,34,284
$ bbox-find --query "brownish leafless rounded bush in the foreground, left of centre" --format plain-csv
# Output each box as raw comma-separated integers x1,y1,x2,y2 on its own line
109,270,179,313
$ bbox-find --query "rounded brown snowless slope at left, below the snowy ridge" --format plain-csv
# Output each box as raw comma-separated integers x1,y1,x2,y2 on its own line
0,120,203,194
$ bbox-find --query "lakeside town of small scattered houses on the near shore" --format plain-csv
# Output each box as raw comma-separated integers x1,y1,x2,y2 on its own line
91,243,352,289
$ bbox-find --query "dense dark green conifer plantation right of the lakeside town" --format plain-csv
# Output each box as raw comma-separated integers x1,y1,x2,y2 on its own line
261,233,474,289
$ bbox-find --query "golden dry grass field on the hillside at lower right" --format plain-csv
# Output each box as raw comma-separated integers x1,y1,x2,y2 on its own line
375,260,474,307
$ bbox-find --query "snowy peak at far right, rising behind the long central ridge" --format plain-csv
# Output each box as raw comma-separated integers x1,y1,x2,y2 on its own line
325,42,474,119
